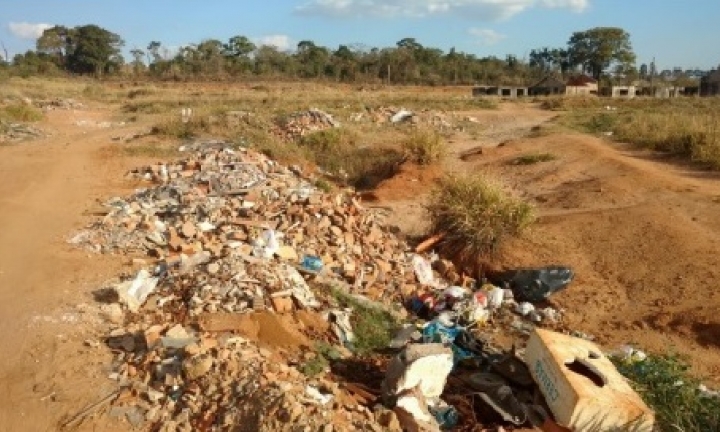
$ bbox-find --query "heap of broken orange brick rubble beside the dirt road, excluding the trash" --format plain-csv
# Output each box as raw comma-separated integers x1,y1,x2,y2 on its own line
70,141,430,430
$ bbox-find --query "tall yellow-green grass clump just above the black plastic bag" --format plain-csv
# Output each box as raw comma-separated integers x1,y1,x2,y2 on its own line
427,175,535,261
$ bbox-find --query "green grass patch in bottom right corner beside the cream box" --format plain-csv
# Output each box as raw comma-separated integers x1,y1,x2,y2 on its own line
613,355,720,432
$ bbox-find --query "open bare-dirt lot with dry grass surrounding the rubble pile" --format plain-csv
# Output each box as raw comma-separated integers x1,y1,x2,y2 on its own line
0,80,720,430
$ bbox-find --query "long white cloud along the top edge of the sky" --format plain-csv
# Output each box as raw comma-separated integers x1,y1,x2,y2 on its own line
295,0,590,21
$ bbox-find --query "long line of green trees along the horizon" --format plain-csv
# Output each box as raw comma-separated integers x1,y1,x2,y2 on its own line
2,24,636,85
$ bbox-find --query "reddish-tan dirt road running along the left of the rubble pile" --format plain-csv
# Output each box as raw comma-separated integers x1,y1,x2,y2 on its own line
0,111,143,431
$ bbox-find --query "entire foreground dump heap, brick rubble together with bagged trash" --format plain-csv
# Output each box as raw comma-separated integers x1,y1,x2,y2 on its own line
70,141,660,432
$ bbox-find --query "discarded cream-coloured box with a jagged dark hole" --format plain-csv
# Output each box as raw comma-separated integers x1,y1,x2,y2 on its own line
525,329,655,432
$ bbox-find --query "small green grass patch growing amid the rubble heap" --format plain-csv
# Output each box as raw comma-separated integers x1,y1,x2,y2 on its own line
332,289,400,356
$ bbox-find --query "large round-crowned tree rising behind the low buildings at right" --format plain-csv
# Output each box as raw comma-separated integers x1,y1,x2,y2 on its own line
568,27,635,79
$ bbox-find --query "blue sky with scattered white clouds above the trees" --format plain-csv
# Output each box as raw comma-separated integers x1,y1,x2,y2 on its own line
0,0,720,69
